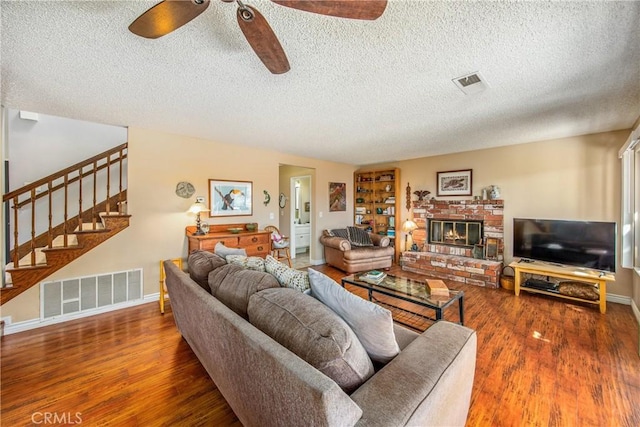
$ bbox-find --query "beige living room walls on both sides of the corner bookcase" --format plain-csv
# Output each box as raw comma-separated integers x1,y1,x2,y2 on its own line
2,128,640,322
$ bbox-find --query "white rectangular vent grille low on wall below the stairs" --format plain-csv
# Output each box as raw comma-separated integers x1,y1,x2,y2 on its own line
40,268,143,320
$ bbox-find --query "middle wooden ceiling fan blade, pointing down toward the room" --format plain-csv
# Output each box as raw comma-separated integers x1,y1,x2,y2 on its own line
238,5,291,74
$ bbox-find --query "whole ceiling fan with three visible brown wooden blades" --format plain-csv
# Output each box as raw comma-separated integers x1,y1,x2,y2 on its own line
129,0,387,74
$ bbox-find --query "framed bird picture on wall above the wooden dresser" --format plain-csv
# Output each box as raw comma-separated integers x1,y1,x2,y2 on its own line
209,179,253,217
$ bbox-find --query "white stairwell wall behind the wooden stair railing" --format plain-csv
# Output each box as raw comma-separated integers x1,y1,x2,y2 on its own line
5,109,127,244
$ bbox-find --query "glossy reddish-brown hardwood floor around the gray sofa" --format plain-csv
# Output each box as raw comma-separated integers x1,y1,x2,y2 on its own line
0,266,640,427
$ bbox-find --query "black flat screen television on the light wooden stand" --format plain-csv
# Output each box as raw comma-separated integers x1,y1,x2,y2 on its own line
513,218,616,272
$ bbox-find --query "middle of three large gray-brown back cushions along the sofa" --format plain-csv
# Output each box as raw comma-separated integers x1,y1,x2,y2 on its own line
209,264,280,319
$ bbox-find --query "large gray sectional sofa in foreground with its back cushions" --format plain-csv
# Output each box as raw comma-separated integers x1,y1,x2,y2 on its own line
164,253,477,427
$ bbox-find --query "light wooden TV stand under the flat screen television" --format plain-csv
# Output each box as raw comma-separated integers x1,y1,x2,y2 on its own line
509,261,615,314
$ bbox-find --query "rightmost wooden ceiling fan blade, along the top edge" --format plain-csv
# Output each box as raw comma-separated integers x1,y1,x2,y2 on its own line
271,0,387,20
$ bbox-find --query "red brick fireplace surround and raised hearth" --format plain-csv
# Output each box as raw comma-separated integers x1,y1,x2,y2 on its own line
400,200,504,288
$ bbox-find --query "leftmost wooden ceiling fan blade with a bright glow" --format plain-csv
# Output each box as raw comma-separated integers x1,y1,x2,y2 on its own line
129,0,209,39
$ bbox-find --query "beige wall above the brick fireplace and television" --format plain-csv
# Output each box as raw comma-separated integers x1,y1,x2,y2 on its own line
372,131,633,297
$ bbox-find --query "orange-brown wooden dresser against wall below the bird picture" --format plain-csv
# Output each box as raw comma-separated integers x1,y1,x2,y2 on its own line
186,224,271,258
